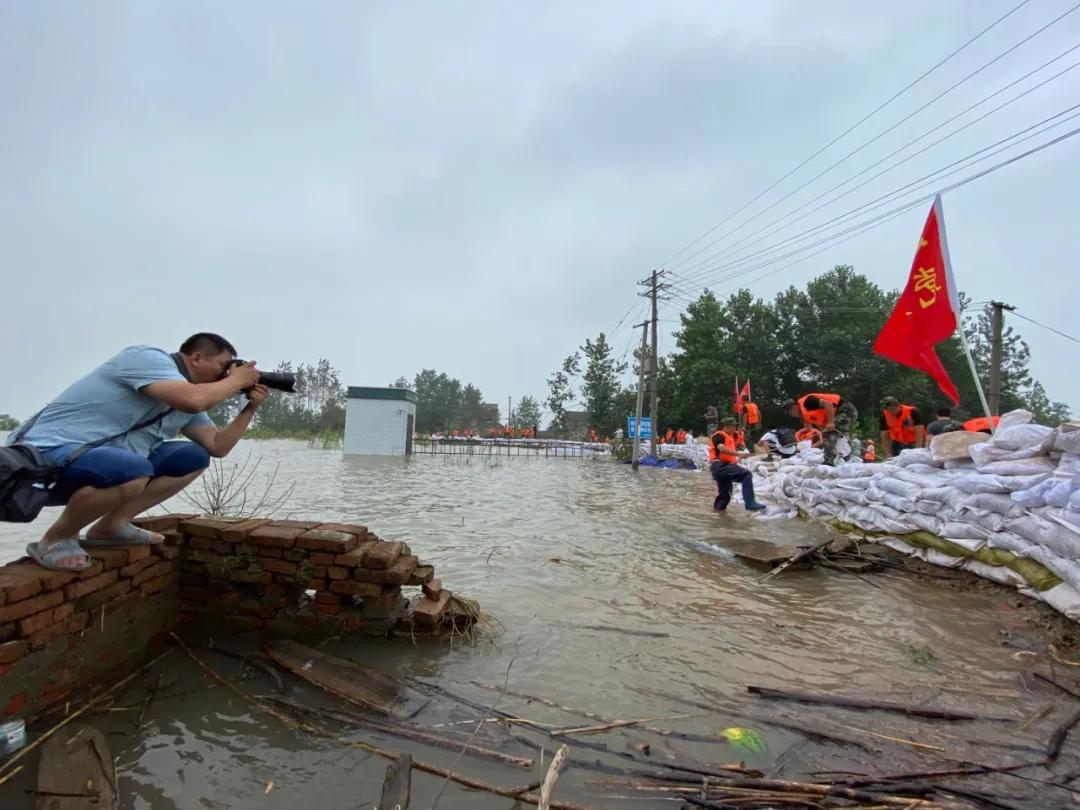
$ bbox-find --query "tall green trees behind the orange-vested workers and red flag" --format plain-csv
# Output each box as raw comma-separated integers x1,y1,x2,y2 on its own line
546,266,1069,435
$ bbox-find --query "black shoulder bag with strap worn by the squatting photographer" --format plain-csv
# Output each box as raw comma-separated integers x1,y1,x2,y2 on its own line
0,408,174,523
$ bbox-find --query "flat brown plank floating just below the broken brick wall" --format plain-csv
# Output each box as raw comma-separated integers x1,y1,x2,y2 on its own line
264,640,429,719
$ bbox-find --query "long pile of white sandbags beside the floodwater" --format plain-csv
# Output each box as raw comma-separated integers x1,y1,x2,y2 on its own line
754,410,1080,620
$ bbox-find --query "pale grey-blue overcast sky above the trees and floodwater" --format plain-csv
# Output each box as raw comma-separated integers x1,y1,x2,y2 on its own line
0,0,1080,425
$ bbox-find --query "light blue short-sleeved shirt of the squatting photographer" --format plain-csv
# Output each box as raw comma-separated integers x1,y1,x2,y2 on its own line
13,346,214,457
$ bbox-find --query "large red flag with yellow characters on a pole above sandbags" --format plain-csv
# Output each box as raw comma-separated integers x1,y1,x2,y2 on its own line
874,197,960,405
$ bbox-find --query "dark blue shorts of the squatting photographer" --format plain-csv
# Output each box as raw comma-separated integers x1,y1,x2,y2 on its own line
45,442,210,505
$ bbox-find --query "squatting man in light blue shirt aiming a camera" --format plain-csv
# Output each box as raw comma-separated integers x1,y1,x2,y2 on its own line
12,332,268,571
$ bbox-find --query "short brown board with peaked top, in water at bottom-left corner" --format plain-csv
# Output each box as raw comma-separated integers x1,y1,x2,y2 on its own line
35,723,120,810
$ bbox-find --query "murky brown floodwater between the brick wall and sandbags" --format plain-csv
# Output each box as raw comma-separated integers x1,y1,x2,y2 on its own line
0,442,1080,810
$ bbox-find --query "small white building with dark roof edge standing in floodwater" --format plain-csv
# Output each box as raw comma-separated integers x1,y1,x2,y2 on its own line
345,386,417,456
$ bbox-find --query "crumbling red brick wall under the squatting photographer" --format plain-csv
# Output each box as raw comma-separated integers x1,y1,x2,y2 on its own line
0,514,451,719
